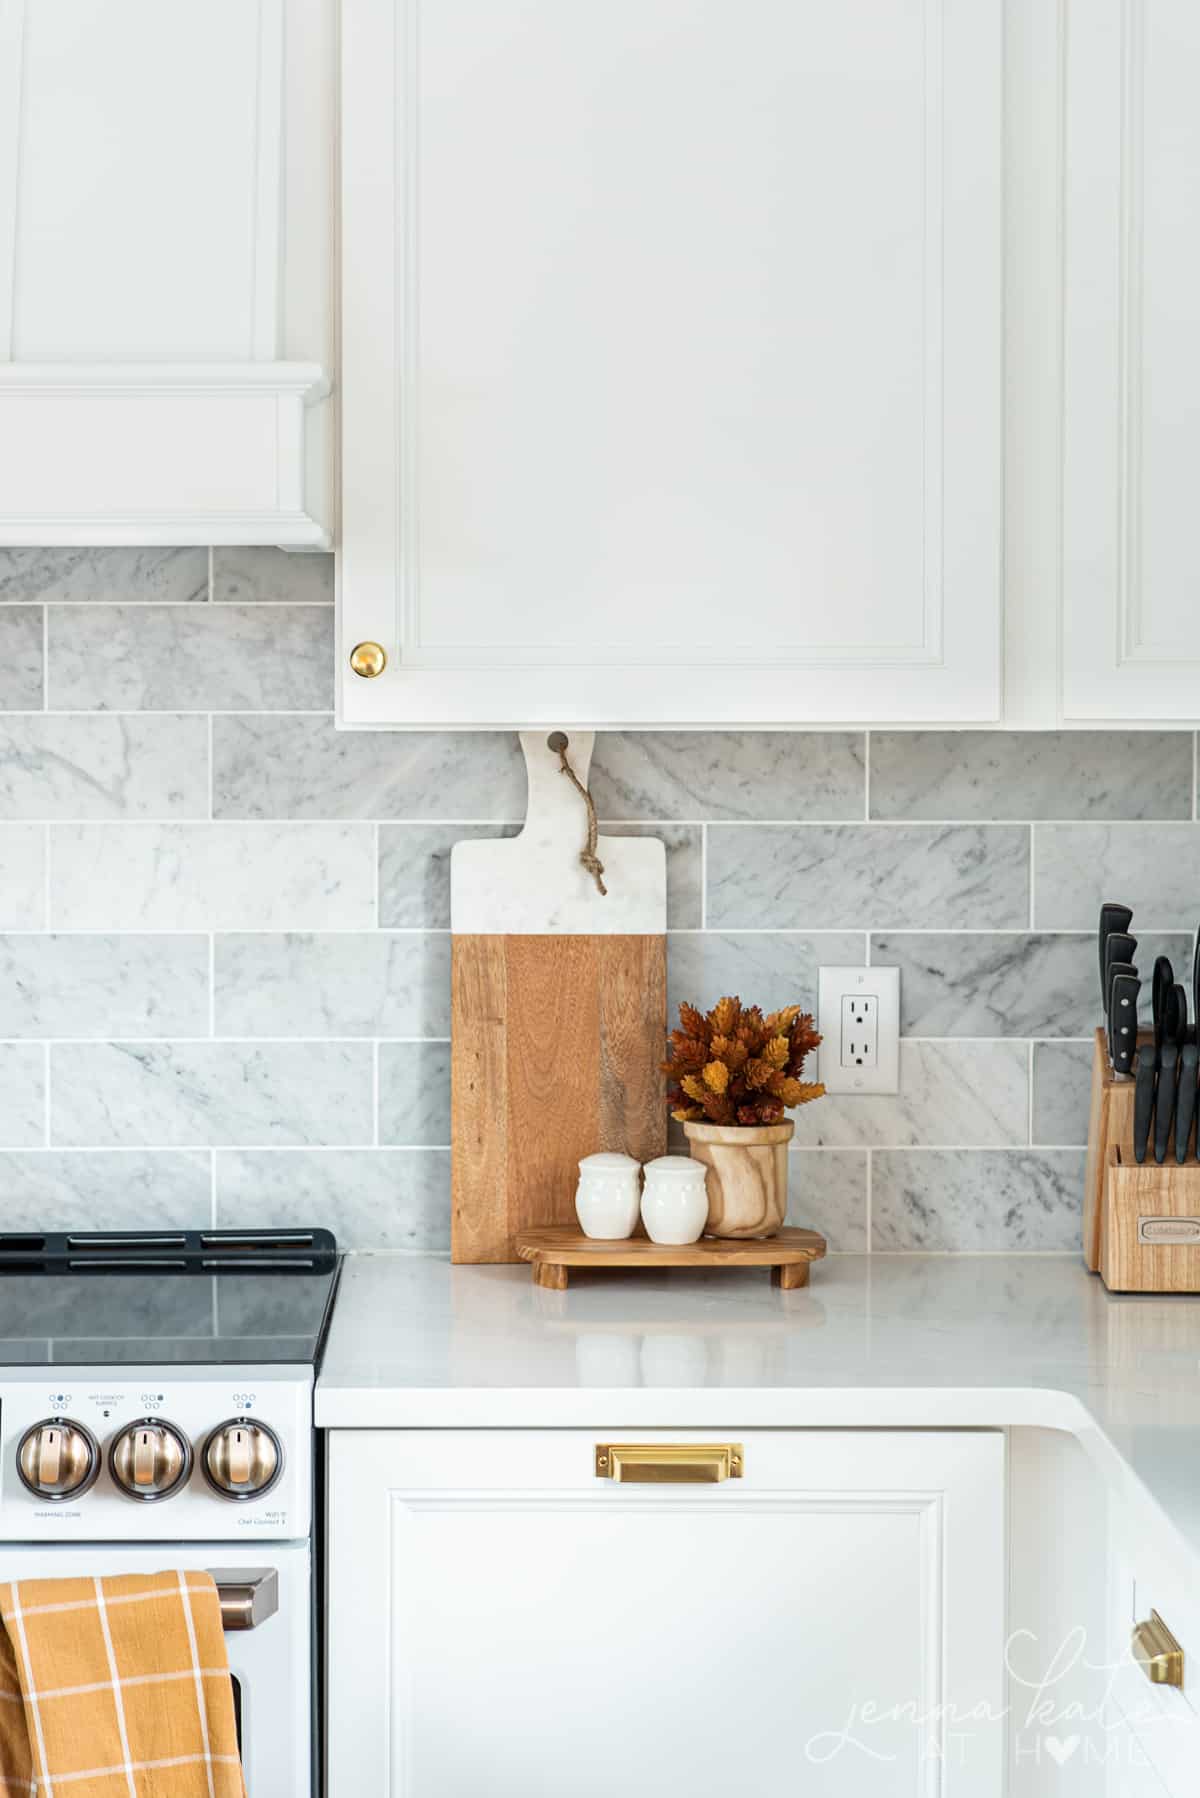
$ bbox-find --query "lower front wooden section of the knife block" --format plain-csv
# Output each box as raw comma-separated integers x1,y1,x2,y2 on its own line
1099,1145,1200,1293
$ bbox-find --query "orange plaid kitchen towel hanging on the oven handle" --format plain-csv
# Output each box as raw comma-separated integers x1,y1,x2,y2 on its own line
0,1571,245,1798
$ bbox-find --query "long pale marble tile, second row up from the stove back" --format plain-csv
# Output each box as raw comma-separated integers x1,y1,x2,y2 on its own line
50,1043,374,1149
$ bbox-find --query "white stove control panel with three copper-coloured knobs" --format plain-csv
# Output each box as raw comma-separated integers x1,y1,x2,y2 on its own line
0,1366,313,1543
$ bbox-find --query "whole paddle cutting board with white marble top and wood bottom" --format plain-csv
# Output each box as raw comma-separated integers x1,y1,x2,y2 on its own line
450,730,667,1262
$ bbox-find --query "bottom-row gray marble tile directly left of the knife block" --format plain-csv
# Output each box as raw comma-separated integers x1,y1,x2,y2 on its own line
871,1149,1085,1253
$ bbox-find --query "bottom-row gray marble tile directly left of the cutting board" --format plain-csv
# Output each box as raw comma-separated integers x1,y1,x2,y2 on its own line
216,1149,450,1255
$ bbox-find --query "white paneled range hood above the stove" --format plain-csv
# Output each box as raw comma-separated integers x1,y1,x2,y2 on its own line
0,0,335,547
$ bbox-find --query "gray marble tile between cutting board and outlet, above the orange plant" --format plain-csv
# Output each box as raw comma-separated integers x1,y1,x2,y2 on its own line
667,931,865,1025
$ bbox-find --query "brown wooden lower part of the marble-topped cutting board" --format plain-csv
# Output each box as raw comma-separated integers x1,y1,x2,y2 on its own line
450,933,667,1262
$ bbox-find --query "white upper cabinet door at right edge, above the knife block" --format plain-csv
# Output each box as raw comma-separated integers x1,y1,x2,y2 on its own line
1061,0,1200,723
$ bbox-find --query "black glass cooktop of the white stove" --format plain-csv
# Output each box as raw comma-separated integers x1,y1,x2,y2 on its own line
0,1230,338,1366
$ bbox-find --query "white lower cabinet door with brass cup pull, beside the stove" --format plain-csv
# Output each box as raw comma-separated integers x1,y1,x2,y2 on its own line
327,1429,1004,1798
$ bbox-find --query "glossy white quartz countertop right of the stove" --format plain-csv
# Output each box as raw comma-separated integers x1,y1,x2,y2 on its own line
317,1255,1200,1555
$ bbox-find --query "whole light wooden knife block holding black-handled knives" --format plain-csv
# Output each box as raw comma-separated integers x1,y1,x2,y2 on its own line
1083,1030,1200,1293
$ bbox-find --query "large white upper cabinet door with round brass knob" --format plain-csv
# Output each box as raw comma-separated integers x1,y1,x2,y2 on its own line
340,0,1004,726
